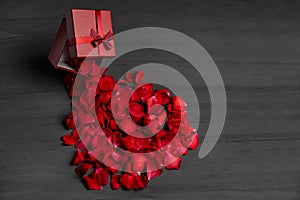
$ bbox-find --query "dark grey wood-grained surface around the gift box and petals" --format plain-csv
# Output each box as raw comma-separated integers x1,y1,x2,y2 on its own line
0,0,300,200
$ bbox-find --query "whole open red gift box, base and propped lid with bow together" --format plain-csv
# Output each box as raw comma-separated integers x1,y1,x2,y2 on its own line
48,9,116,72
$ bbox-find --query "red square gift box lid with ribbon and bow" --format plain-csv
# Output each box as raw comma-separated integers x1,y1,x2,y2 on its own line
66,9,116,58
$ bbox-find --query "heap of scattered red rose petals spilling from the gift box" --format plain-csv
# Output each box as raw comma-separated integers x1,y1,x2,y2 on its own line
62,61,199,190
